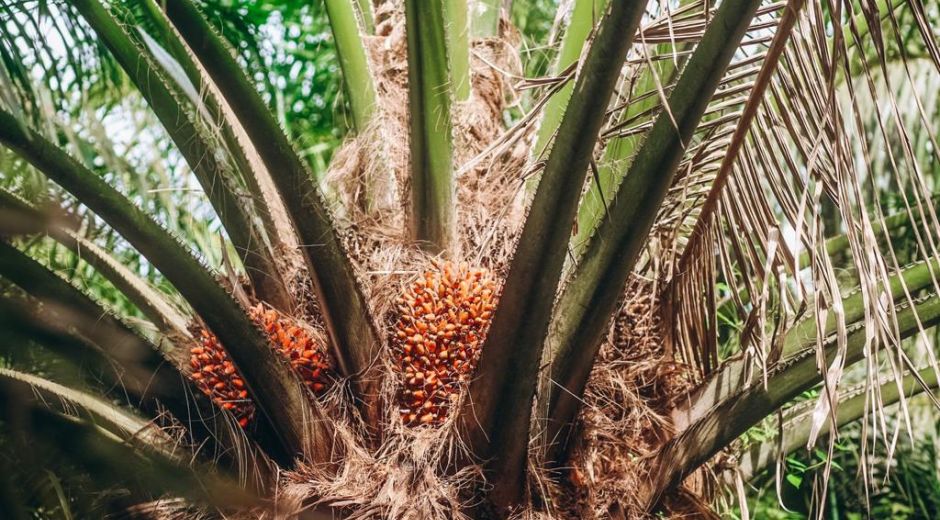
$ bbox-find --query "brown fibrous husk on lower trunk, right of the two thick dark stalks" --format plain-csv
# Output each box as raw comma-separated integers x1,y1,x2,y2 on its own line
548,277,710,518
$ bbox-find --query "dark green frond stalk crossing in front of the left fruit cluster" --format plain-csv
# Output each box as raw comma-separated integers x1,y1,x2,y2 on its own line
0,111,330,460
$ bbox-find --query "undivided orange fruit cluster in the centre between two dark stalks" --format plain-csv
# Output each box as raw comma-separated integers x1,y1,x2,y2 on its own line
391,263,497,426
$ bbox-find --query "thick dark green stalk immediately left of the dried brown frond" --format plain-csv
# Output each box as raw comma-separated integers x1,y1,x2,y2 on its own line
544,0,760,461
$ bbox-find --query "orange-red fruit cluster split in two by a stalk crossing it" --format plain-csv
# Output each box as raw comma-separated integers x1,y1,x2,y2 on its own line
190,303,333,427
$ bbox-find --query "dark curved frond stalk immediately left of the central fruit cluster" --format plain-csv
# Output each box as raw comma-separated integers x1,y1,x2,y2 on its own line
165,0,381,423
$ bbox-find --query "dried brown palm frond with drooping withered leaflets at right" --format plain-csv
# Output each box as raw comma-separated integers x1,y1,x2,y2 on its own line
640,3,938,508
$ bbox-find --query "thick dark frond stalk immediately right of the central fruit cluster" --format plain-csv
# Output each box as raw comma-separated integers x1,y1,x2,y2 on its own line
460,1,646,510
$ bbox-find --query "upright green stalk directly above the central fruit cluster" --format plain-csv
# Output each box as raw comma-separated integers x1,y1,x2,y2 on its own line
405,0,456,252
